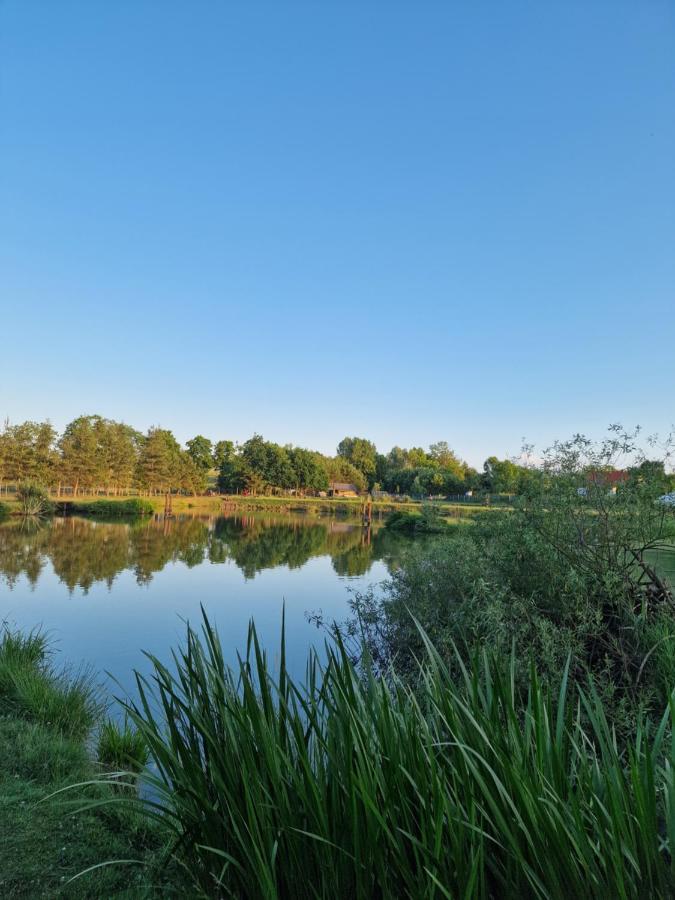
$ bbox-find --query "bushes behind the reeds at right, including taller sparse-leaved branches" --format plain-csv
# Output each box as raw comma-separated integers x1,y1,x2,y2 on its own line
347,435,675,735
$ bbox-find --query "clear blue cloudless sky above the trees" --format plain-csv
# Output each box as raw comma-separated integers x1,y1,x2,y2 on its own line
0,0,675,472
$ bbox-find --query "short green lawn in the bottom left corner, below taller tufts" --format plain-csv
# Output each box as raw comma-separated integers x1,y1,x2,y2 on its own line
0,716,172,898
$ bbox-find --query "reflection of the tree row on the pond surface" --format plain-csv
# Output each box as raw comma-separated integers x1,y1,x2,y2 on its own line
0,514,409,593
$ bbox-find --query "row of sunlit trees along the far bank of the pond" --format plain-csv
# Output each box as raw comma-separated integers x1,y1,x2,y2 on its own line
0,415,672,497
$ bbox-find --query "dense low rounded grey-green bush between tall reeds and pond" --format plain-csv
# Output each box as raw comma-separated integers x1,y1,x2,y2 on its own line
354,502,675,734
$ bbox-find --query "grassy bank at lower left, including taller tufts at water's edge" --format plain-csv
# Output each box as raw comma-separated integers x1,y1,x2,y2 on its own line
0,631,173,898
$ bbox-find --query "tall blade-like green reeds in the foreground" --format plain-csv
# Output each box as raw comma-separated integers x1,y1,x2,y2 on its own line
117,617,675,900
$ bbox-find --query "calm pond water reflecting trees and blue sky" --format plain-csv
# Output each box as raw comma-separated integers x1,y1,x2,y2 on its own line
0,513,420,695
